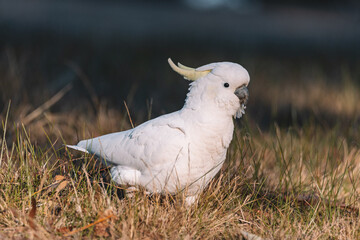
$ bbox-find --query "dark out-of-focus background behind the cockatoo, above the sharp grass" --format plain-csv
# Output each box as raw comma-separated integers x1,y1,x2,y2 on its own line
0,0,360,144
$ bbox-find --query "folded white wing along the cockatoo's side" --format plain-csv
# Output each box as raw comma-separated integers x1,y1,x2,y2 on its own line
77,112,187,170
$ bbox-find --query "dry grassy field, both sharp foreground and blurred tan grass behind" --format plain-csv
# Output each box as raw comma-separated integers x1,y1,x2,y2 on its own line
0,48,360,239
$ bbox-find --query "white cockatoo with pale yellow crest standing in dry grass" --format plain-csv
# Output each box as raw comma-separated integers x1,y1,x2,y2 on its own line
67,58,250,205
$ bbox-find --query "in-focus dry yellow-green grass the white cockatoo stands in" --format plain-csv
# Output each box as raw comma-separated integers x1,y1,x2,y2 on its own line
0,102,360,239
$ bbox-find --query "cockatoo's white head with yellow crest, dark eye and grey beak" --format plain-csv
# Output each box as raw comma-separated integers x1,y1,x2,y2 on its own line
168,58,250,118
